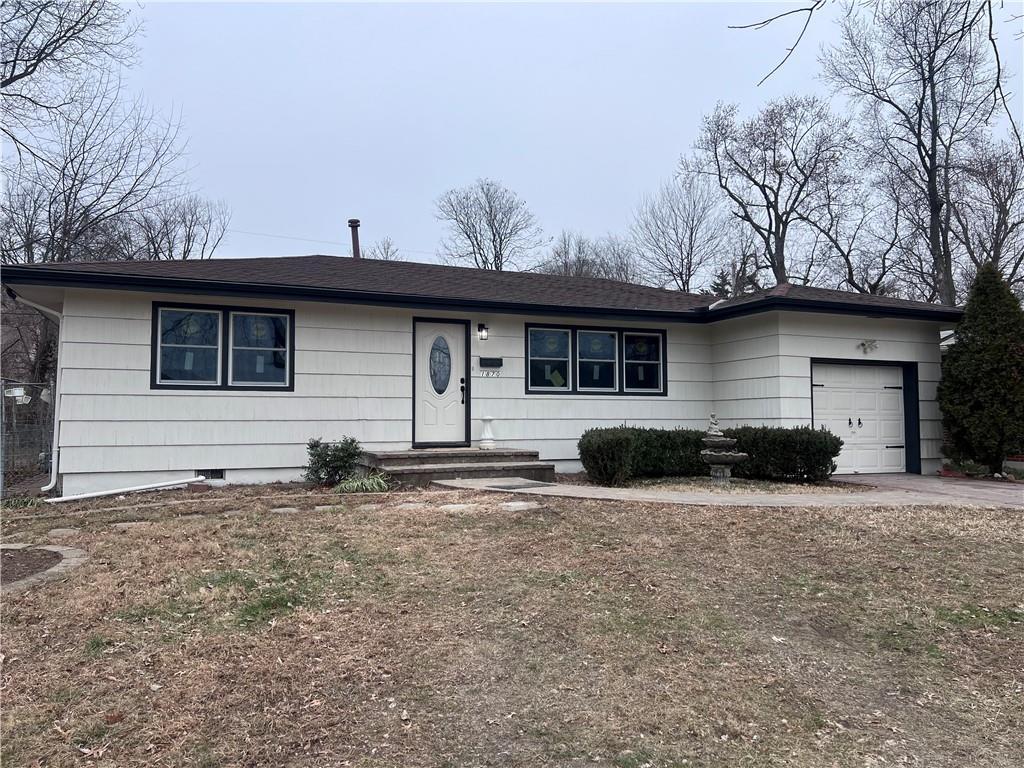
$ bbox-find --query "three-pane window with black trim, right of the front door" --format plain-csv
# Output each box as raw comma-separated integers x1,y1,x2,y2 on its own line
526,324,668,395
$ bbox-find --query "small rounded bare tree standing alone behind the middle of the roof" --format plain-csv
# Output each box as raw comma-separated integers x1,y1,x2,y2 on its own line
437,178,544,271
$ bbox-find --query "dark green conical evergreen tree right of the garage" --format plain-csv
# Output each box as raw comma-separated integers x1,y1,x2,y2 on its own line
938,264,1024,472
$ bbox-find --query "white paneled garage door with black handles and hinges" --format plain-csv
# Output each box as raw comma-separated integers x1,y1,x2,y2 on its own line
811,362,906,474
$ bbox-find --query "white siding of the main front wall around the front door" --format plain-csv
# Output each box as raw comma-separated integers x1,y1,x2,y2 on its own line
58,290,712,495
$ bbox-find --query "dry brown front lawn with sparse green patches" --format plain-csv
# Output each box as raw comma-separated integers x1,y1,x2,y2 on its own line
2,493,1024,768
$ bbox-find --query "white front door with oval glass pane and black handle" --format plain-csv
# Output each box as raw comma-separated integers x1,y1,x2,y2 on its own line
413,321,469,445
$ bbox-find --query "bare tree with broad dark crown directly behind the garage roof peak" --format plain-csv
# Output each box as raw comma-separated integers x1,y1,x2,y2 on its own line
696,96,849,284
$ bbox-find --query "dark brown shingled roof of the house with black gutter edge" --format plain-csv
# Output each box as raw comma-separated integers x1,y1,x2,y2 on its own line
2,256,961,323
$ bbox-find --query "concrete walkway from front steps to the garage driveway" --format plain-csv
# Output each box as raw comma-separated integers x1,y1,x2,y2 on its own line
434,475,1024,509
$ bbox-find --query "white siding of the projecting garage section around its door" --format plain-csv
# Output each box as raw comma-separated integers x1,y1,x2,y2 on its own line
711,312,943,473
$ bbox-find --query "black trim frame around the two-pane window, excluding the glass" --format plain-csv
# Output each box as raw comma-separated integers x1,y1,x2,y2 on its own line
150,301,295,392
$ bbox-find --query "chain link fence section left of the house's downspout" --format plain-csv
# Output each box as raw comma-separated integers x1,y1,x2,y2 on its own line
0,379,53,499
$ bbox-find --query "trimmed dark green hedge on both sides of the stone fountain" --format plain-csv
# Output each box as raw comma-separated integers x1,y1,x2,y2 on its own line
579,426,843,485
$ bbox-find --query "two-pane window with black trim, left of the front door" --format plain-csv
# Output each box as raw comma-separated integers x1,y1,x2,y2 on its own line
151,303,295,390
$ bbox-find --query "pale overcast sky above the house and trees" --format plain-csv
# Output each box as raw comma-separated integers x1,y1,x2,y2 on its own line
128,2,1022,261
